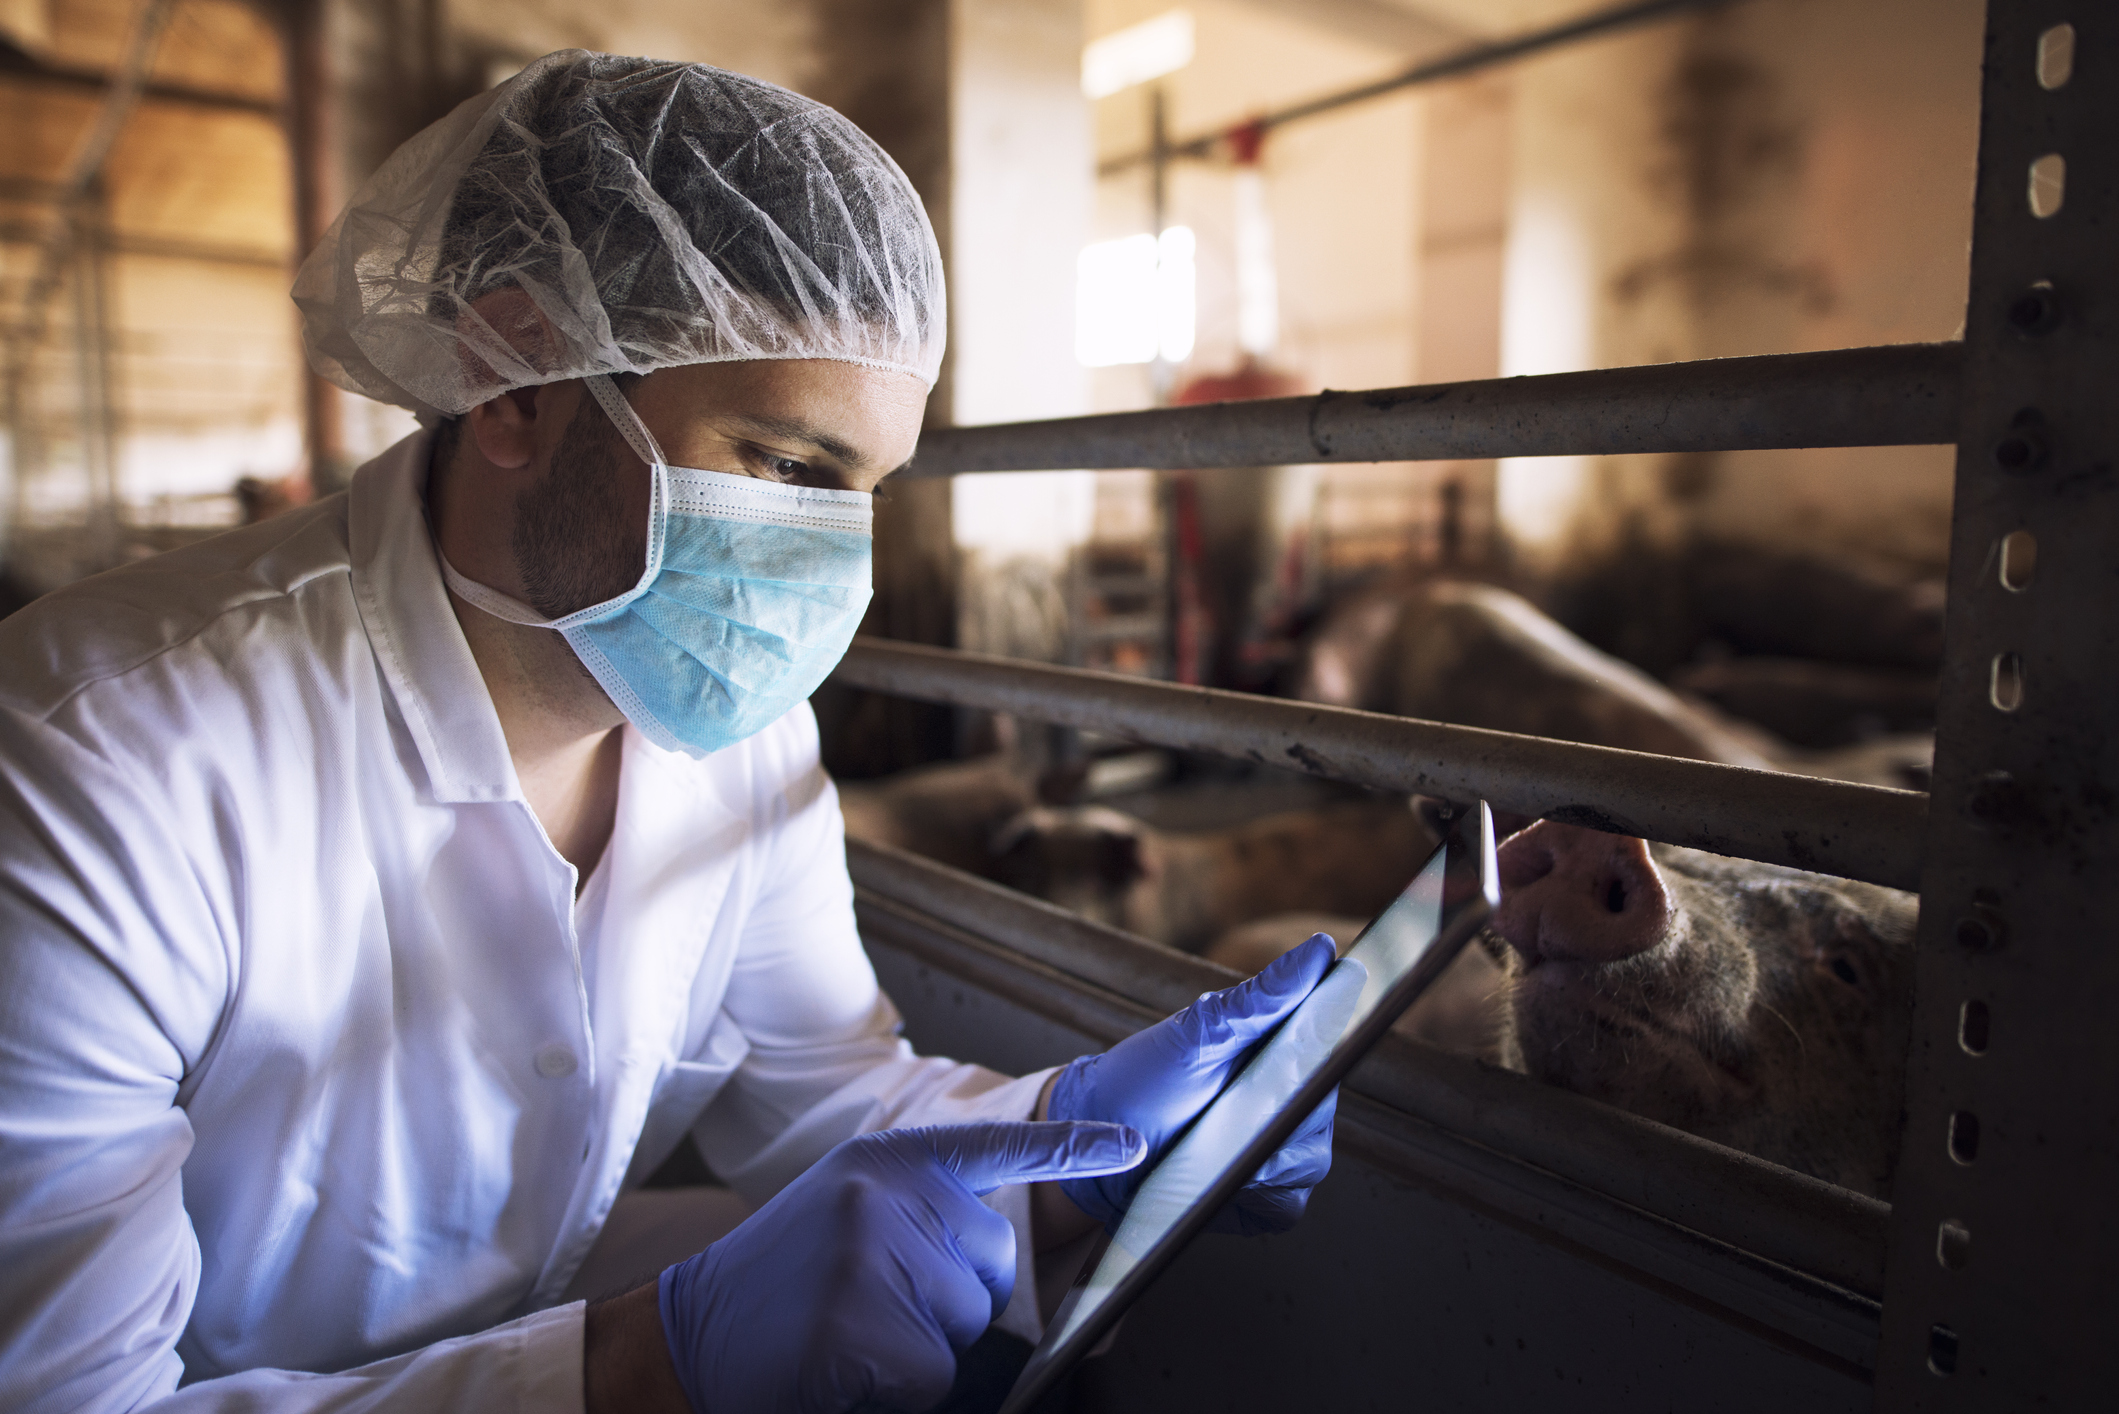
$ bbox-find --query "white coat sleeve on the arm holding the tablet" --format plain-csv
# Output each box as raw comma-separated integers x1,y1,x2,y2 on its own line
693,727,1051,1340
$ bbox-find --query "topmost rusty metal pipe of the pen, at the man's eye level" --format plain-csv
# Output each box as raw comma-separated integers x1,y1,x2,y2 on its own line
898,343,1960,477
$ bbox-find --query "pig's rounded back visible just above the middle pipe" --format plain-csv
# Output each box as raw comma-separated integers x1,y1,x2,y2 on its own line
1290,579,1774,767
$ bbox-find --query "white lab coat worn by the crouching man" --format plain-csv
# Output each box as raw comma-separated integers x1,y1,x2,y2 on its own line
0,435,1043,1414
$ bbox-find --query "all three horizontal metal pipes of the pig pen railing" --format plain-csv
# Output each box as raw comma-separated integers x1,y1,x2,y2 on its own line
835,343,1962,1331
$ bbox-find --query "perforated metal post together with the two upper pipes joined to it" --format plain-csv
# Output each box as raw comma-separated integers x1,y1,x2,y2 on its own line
822,0,2119,1412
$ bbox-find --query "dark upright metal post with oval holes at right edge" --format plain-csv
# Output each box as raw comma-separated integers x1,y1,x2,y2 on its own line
1875,0,2119,1414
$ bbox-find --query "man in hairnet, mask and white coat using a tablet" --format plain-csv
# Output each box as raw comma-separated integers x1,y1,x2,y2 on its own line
0,51,1331,1414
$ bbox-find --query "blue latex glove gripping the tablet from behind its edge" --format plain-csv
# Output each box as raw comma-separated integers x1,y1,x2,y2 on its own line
1047,933,1339,1236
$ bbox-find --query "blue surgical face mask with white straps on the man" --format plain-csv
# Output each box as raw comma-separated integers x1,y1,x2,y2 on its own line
441,375,875,757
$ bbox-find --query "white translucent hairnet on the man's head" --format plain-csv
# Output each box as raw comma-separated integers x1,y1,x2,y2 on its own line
295,49,947,413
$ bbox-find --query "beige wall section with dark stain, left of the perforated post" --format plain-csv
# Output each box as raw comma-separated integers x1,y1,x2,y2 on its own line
1500,0,1981,572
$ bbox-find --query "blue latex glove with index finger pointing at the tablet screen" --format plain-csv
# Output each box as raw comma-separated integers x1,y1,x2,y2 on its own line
661,1121,1146,1414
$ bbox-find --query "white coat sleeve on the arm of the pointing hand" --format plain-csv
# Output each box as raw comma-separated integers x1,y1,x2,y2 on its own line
0,712,583,1414
